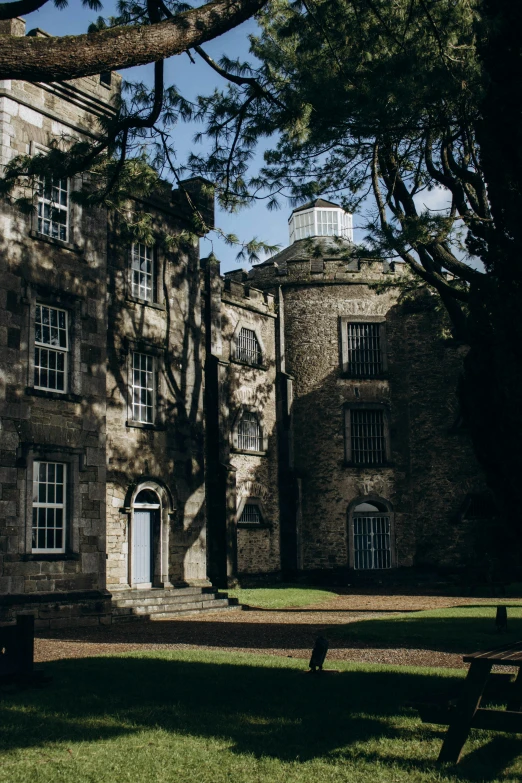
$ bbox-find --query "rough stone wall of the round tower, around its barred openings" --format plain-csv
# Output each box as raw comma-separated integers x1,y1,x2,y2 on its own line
242,251,484,570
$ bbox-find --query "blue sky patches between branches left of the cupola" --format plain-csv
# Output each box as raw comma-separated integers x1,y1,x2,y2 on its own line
19,0,300,271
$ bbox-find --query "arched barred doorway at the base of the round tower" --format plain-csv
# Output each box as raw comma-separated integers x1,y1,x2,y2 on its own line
348,498,395,571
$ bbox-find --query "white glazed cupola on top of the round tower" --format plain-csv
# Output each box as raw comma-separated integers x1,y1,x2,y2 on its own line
288,198,353,244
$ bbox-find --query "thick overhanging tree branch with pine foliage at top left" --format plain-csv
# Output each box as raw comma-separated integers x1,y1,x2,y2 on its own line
0,0,275,260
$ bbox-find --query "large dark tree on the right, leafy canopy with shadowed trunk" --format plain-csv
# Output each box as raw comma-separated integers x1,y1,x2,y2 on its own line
192,0,522,549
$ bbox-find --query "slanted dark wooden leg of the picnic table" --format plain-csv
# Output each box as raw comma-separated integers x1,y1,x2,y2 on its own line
439,660,493,764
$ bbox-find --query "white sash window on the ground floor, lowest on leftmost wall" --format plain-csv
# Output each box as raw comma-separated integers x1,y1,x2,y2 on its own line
32,462,67,552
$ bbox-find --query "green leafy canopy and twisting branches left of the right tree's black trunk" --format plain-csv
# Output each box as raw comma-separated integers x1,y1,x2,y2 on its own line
188,0,493,333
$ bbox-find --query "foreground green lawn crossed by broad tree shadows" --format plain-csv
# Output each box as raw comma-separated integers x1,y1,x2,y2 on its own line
0,651,522,783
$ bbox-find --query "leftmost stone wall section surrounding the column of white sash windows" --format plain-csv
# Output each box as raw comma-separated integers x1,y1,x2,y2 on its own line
0,20,112,608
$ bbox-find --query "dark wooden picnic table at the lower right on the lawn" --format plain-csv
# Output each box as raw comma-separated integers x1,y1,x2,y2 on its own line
421,642,522,764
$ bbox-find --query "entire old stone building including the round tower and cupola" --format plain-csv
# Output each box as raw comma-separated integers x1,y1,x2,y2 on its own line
0,19,483,627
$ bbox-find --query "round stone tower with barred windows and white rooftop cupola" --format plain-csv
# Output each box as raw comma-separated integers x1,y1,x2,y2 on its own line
225,199,486,575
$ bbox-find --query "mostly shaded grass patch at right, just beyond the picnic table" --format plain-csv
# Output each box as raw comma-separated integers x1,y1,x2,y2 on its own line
328,601,522,654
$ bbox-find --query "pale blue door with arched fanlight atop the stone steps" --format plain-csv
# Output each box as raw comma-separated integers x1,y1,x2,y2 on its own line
131,488,161,587
